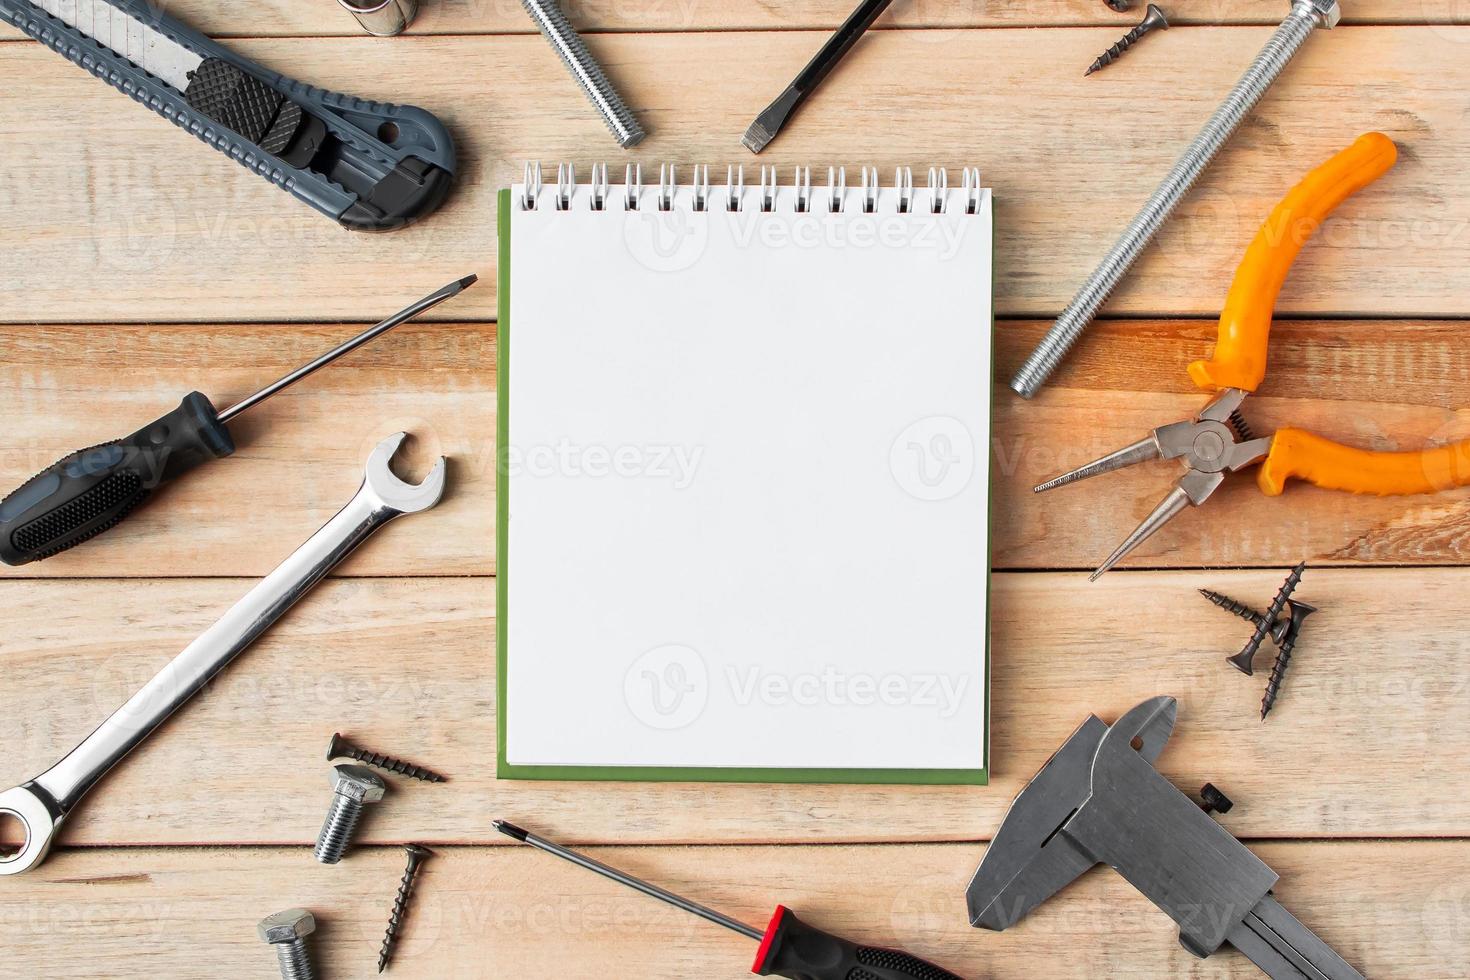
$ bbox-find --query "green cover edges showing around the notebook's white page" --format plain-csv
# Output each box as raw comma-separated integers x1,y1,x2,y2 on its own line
495,188,995,786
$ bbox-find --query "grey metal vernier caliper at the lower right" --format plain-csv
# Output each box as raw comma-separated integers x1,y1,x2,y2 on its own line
966,698,1363,980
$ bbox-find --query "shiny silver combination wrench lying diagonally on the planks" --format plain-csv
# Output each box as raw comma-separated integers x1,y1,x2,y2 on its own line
0,432,445,874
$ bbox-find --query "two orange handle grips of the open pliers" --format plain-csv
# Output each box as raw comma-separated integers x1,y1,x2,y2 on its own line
1189,132,1470,497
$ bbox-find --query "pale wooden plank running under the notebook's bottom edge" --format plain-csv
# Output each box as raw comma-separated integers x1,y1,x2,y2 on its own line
0,570,1470,845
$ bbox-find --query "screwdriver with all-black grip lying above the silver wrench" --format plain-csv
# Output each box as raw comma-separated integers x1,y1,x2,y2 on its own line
0,276,476,566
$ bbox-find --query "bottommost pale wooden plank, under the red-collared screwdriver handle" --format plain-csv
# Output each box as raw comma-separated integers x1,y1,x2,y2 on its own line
0,840,1470,980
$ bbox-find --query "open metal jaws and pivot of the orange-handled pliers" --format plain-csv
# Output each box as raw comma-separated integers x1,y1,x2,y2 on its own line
1035,388,1274,582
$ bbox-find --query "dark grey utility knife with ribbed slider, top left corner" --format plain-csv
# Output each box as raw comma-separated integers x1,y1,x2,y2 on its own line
0,0,454,231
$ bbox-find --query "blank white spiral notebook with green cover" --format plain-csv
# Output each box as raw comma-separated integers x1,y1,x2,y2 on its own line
497,166,992,783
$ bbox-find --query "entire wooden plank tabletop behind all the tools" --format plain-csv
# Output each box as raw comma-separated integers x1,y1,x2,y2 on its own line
0,0,1470,979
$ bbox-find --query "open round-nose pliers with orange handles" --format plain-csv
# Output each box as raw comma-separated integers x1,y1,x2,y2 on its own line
1035,132,1470,582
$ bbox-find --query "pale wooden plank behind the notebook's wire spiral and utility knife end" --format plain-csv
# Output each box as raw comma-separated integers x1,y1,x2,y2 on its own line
0,26,1470,322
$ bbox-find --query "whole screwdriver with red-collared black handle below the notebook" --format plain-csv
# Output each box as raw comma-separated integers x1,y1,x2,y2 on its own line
492,820,963,980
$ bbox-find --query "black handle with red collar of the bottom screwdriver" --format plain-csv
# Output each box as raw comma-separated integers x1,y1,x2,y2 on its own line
751,905,964,980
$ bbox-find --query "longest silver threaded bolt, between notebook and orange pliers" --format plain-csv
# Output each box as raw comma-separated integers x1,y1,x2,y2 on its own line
1011,0,1342,398
